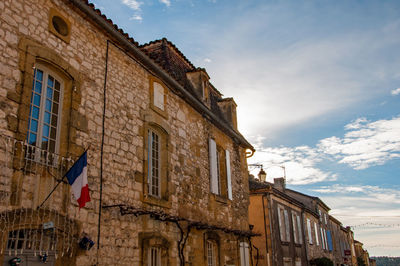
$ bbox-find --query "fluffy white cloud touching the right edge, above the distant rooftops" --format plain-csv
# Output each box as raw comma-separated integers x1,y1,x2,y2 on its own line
318,116,400,170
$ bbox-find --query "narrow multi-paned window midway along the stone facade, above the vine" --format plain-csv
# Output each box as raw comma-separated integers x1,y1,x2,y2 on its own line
148,130,161,197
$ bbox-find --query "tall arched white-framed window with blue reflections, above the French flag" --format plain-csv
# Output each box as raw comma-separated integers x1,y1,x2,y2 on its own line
27,66,63,153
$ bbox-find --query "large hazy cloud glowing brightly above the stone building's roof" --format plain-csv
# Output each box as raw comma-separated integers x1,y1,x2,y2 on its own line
191,4,400,138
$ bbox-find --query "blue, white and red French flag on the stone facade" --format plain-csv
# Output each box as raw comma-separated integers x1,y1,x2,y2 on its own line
65,151,90,208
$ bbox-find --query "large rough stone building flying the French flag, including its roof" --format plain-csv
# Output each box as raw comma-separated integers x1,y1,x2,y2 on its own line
0,0,254,266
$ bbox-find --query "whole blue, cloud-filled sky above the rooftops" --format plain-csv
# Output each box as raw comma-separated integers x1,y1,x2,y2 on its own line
90,0,400,256
